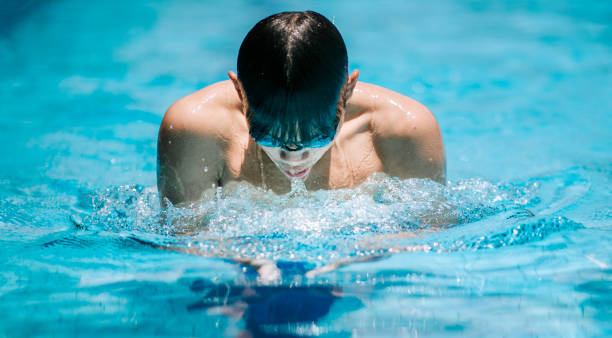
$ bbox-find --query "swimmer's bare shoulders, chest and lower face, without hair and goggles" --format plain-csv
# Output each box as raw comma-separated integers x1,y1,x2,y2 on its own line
158,78,445,204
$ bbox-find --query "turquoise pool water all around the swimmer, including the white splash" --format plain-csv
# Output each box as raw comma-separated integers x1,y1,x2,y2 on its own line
0,0,612,337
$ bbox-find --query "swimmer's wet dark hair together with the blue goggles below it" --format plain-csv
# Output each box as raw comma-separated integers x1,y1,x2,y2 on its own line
238,11,348,145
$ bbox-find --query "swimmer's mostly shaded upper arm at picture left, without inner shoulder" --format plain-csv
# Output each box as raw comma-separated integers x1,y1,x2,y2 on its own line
157,100,224,207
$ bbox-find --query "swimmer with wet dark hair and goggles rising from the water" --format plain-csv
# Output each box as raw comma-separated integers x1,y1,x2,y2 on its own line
157,11,446,205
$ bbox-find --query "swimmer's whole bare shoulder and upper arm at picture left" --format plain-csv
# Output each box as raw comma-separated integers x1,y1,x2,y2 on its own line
157,81,248,204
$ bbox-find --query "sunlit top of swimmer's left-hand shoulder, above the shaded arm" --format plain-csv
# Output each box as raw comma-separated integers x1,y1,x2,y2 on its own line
160,80,243,138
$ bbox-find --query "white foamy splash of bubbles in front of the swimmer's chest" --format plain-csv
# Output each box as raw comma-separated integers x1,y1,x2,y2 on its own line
77,173,560,266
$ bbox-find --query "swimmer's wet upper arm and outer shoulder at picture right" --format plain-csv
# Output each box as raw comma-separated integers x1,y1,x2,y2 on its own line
373,98,446,184
